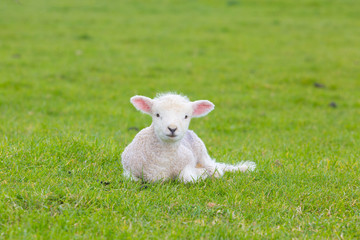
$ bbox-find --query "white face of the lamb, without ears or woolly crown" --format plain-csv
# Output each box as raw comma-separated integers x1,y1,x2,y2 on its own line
152,101,193,142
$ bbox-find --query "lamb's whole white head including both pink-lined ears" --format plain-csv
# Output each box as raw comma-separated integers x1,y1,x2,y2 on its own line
130,93,214,142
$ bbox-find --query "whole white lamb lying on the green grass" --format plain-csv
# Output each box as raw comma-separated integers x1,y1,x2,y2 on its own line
121,93,256,183
